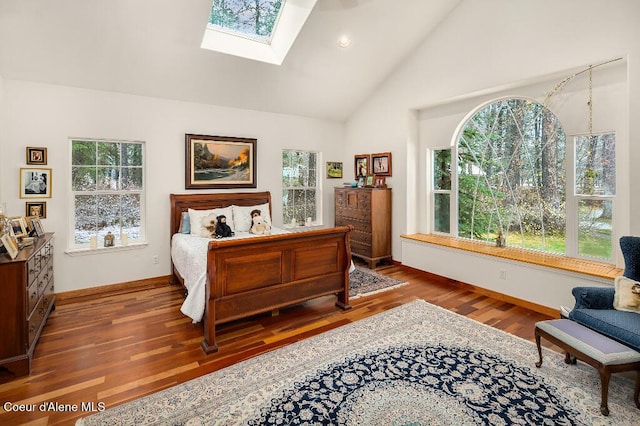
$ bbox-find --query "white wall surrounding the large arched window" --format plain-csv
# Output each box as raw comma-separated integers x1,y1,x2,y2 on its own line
346,0,640,306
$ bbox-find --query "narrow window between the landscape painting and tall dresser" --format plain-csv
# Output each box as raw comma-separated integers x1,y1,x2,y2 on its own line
282,150,322,226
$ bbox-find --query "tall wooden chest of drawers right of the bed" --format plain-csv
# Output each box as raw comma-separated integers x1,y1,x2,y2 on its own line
335,188,391,269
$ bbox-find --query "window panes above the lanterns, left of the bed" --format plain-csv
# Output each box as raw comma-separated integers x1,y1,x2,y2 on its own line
69,140,144,248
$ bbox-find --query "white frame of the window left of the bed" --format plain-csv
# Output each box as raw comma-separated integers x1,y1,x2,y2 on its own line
65,137,148,255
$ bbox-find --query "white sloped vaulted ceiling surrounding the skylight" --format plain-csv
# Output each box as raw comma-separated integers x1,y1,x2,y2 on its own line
0,0,461,121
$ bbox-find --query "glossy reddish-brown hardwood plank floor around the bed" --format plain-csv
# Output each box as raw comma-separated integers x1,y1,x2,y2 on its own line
0,265,549,425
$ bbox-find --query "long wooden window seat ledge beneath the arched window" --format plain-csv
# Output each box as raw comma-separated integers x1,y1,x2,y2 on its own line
401,234,623,279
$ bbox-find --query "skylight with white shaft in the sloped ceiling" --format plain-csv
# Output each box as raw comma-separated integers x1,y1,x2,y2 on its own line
201,0,317,65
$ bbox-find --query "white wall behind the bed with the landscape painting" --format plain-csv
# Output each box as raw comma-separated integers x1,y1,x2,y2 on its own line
0,80,344,292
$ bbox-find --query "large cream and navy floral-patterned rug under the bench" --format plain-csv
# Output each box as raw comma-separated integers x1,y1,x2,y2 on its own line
78,300,640,425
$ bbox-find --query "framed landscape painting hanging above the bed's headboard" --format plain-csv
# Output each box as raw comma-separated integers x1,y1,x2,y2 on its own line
185,134,257,189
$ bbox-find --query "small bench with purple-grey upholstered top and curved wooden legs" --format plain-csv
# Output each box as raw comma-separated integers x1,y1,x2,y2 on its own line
535,319,640,416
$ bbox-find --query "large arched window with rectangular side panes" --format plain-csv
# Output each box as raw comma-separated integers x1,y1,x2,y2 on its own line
431,98,615,259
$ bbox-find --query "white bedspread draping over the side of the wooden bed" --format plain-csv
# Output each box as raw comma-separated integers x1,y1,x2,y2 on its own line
171,228,289,323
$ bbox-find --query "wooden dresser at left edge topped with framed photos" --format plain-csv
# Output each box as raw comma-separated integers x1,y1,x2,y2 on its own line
0,233,55,376
